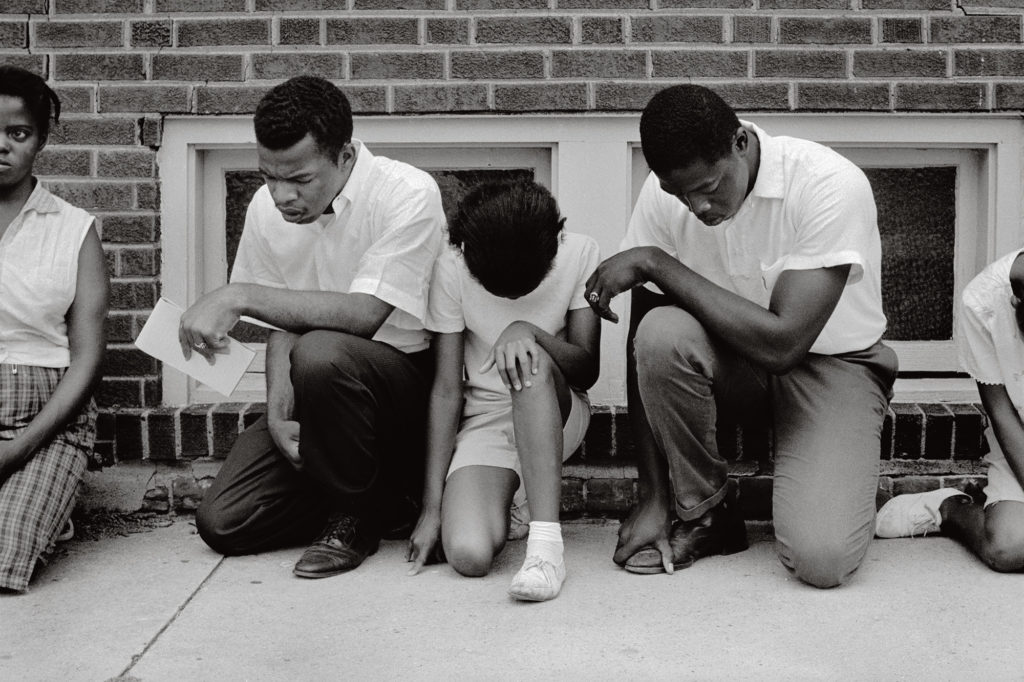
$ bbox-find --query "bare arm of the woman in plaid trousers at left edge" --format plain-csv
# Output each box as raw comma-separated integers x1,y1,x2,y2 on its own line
0,227,110,471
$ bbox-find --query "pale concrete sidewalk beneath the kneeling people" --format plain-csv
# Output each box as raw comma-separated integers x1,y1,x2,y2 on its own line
0,517,1024,682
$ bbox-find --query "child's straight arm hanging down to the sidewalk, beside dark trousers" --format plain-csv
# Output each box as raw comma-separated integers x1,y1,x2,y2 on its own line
406,332,464,576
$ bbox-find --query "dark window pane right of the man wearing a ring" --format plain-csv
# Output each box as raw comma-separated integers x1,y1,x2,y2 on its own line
864,167,956,341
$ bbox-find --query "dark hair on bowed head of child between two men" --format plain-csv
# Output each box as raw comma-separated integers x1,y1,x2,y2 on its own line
449,181,565,298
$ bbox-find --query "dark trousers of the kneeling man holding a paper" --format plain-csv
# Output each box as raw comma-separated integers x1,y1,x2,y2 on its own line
196,331,433,554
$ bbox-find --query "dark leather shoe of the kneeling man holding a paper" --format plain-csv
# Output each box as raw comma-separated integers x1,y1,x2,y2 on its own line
292,512,380,578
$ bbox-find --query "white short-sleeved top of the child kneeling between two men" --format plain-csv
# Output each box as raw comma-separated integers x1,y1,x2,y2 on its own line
427,232,600,417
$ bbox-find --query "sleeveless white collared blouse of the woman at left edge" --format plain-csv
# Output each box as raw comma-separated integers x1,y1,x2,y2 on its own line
0,181,92,368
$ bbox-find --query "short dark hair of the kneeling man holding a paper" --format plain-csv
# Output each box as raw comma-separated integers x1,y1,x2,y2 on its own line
253,76,352,163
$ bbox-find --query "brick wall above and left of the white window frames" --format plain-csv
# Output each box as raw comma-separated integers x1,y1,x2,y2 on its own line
0,0,1024,493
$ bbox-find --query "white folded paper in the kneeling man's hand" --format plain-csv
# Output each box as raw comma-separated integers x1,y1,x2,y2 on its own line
135,298,256,395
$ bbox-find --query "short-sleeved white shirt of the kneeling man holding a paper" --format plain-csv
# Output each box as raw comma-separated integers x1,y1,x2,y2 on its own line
231,138,445,352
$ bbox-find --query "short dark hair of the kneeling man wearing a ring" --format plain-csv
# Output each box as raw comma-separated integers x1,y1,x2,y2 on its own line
640,85,739,175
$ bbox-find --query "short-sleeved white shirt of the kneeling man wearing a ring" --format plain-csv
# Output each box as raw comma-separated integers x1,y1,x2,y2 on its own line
622,122,886,355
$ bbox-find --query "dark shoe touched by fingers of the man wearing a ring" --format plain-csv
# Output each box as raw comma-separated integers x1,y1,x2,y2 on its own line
625,483,749,574
